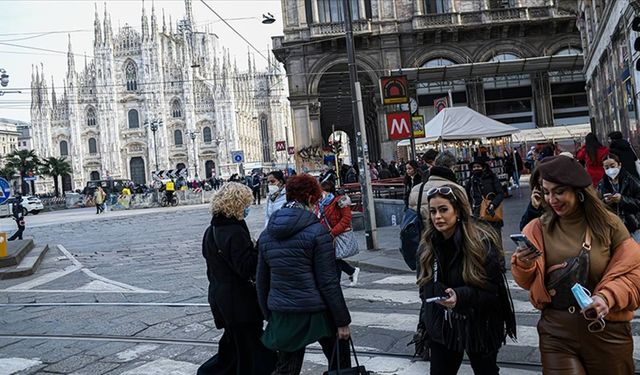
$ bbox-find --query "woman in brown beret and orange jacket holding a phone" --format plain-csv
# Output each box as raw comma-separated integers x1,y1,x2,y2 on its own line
511,156,640,375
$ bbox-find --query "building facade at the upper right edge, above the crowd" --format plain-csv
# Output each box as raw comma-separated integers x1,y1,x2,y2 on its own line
578,0,640,145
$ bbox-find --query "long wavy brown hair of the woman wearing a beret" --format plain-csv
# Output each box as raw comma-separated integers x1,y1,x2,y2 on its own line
542,186,615,243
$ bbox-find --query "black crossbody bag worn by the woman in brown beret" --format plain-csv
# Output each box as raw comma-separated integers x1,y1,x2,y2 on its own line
545,229,591,310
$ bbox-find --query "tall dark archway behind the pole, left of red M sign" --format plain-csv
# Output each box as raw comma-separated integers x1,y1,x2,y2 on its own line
318,64,381,164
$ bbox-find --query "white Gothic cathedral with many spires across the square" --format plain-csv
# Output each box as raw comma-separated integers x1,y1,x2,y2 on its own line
31,0,291,191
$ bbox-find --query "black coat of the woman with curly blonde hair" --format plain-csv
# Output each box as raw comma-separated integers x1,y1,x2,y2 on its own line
202,216,263,329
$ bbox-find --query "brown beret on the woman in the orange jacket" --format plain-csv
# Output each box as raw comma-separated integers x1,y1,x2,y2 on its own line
538,155,593,189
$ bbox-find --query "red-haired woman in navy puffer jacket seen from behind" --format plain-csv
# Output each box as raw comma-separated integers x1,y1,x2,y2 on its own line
257,175,351,375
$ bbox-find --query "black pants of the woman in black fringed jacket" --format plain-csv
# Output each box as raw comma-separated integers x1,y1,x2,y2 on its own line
431,342,500,375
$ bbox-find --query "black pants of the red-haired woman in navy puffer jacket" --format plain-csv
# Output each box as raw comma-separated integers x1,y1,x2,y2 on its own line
272,337,351,375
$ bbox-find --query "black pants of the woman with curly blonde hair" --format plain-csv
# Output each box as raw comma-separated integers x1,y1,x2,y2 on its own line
196,324,277,375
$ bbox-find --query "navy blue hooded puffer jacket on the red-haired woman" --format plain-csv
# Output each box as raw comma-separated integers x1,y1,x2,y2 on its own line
256,204,351,327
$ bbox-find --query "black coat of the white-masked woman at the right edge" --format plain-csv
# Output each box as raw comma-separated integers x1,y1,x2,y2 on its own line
598,170,640,233
